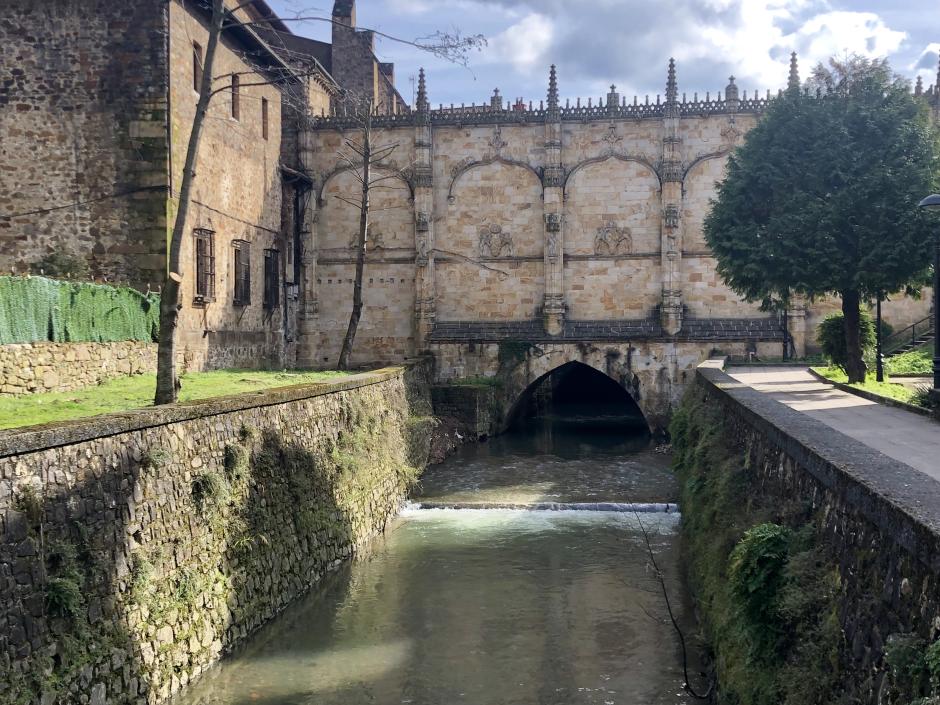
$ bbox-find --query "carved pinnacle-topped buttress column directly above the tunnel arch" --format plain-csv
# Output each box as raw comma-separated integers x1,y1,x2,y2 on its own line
542,64,565,335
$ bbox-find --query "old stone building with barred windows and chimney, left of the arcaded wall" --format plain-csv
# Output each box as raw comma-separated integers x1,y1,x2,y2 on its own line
0,0,407,368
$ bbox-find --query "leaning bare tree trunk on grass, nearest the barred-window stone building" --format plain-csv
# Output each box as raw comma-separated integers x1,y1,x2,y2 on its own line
153,0,225,404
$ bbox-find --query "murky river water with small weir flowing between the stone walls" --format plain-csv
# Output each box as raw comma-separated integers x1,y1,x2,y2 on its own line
183,417,694,705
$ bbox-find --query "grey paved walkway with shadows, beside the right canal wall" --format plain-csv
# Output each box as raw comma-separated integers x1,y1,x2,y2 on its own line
727,367,940,480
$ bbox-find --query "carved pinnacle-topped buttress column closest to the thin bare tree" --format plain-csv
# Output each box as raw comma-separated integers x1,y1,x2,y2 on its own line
414,69,435,351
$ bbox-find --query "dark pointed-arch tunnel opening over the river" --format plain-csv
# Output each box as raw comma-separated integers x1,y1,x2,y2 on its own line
510,362,650,449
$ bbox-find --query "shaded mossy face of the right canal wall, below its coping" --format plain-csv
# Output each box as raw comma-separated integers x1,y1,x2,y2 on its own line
670,383,940,705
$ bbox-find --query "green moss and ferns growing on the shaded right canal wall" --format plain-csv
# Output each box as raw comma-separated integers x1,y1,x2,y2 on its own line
670,390,848,705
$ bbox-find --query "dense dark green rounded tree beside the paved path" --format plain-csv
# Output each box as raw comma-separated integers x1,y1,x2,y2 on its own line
704,56,938,382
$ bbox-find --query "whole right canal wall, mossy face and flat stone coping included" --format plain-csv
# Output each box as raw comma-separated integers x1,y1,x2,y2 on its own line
671,376,940,705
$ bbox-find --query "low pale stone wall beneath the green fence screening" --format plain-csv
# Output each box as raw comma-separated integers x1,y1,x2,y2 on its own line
0,340,157,395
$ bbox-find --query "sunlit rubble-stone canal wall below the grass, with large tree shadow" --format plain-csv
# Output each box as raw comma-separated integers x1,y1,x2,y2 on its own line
0,367,430,704
